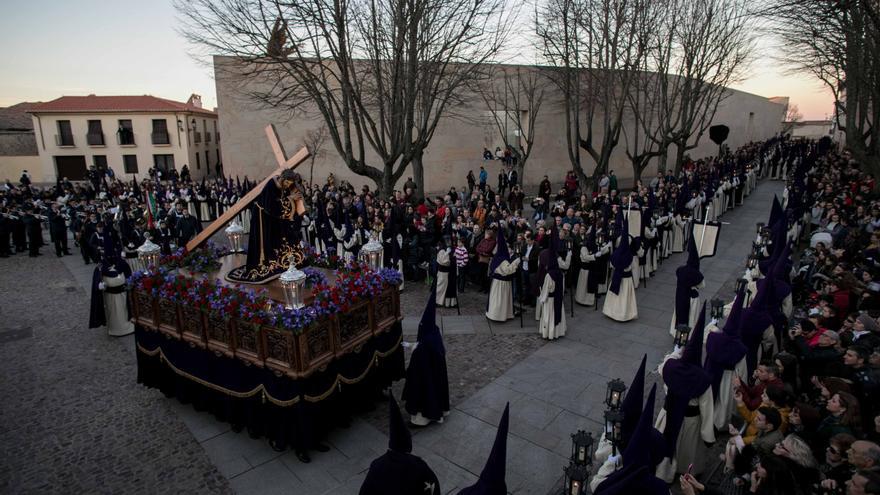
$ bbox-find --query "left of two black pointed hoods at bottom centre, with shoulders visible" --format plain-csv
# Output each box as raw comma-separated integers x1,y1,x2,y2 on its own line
359,395,443,495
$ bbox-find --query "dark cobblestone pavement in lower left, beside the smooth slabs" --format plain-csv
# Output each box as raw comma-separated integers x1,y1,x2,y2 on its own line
0,254,231,494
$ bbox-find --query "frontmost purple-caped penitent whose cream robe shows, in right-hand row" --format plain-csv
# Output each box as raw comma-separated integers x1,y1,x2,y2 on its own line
657,303,715,483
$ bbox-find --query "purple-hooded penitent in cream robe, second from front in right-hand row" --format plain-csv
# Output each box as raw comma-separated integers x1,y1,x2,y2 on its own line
706,291,748,430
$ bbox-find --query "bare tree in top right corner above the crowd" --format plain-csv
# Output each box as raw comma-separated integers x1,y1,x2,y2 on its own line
759,0,880,175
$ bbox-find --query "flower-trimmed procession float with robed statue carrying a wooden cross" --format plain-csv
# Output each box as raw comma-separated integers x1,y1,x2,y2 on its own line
129,126,404,449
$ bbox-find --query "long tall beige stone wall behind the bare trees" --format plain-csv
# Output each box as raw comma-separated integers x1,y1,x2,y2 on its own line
214,57,785,196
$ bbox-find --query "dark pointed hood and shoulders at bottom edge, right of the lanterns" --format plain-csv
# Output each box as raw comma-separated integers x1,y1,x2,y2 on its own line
591,384,669,495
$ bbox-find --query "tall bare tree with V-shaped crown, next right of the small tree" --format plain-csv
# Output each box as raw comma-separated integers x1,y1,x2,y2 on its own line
537,0,652,192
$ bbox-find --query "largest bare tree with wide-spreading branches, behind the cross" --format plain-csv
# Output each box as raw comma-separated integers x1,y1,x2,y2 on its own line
175,0,516,198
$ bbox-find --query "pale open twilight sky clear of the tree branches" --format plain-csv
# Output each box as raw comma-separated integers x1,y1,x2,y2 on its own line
0,0,832,120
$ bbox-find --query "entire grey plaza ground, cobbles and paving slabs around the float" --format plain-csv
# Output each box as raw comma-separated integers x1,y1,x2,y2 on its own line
0,181,782,494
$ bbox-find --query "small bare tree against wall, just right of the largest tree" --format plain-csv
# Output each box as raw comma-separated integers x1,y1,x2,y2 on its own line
476,66,548,183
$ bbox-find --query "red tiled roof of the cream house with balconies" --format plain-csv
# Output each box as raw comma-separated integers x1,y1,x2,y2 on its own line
29,95,217,116
